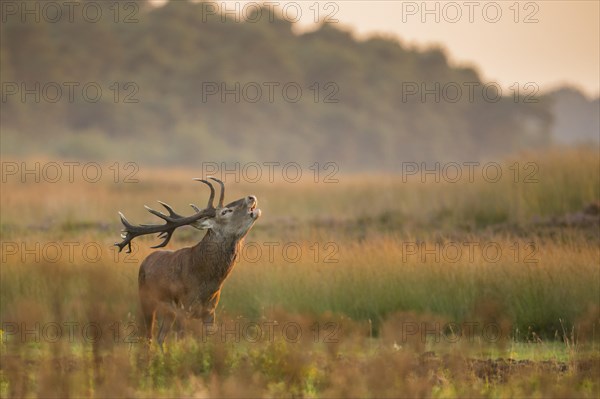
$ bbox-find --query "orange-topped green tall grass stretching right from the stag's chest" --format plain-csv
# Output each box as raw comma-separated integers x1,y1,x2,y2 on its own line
221,234,600,335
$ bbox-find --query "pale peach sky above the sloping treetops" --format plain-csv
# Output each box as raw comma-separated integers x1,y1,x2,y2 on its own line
156,0,600,96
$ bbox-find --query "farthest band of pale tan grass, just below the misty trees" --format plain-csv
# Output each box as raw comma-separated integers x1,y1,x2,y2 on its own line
0,149,600,233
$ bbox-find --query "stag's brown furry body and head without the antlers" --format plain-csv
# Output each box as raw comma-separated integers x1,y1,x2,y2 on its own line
138,196,260,348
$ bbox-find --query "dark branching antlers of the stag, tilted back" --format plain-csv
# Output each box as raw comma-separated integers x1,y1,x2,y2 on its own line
115,177,225,253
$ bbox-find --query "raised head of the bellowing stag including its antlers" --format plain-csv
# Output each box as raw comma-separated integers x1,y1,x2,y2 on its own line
115,177,261,252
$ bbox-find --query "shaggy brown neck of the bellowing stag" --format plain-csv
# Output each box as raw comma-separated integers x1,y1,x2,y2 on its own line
192,230,243,283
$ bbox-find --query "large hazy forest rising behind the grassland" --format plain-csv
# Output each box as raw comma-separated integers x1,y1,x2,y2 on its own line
0,1,568,170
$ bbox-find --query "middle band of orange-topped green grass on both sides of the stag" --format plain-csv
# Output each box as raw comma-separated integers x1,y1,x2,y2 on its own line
0,237,600,338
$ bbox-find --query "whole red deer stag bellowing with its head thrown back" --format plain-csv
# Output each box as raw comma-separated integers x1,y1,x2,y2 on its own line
115,177,261,350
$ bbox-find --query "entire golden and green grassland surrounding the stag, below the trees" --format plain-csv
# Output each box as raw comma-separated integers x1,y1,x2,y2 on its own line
0,149,600,398
